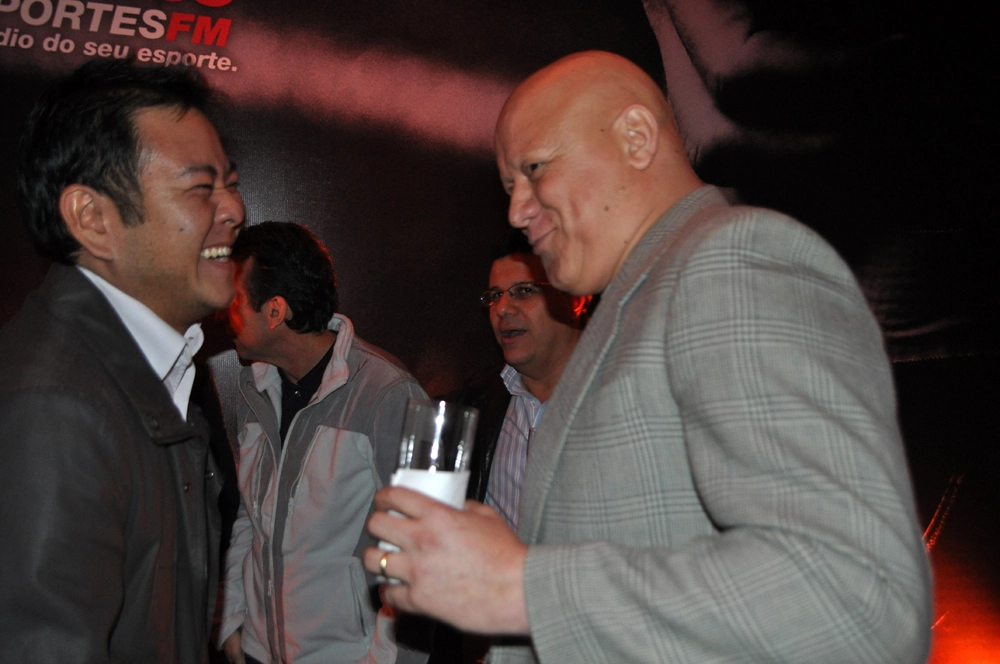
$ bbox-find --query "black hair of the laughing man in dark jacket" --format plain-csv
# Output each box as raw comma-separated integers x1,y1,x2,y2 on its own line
17,60,211,264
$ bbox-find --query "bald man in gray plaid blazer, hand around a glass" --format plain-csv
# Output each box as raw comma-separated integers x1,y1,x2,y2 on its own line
365,53,931,664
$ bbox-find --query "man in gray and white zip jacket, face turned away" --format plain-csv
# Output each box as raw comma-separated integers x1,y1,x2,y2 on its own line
219,222,426,664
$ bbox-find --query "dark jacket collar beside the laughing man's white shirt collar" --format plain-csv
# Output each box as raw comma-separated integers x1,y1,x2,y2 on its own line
39,264,196,445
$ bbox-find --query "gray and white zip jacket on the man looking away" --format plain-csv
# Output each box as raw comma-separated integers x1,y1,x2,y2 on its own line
219,314,426,664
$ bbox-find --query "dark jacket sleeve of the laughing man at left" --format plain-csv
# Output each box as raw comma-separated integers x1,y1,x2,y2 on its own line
0,389,133,663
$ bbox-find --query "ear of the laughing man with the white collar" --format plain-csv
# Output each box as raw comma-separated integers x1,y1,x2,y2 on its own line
59,184,123,261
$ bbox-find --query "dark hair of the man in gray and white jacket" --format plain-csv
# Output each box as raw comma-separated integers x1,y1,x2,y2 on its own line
232,221,337,334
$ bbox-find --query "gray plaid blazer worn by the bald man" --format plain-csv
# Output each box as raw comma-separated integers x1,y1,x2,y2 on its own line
489,187,931,664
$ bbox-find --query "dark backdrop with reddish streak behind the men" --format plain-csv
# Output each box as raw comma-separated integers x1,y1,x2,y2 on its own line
0,0,1000,652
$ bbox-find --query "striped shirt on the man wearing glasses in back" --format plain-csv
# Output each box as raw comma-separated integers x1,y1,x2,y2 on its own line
485,365,545,531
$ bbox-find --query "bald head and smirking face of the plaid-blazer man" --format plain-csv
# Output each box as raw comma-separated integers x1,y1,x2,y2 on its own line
496,51,701,295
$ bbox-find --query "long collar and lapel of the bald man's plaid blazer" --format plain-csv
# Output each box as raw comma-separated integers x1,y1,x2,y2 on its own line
518,186,728,544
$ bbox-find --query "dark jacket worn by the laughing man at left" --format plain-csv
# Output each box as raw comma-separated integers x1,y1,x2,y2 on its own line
0,265,219,664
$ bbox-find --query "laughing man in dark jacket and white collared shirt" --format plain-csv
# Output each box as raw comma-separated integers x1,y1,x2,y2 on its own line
0,61,243,664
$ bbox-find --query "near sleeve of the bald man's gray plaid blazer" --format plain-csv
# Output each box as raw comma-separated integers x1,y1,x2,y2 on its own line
524,217,931,664
